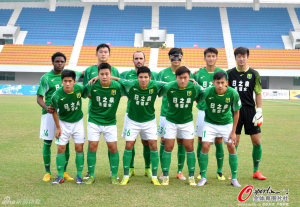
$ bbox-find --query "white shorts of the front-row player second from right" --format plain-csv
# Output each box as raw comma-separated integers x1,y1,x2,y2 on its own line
164,120,194,139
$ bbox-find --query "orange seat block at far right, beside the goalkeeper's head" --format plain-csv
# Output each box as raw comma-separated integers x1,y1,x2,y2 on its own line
249,49,300,70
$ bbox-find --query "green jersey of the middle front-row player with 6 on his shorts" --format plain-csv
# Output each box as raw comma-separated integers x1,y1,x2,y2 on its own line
119,79,165,123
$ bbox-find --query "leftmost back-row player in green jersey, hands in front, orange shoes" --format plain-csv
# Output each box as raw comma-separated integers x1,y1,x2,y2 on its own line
37,52,81,182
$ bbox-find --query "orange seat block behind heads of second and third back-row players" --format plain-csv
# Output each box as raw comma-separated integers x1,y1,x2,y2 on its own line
77,46,150,67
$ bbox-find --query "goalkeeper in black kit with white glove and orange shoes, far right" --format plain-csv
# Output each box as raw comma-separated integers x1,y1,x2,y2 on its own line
227,47,267,180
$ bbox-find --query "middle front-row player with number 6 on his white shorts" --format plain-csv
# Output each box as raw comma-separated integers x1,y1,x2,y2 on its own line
113,66,164,185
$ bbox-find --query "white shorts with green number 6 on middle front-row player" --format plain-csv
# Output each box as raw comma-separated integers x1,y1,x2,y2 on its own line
125,117,157,141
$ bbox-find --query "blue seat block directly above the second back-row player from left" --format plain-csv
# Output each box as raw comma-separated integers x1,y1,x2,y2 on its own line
83,5,152,46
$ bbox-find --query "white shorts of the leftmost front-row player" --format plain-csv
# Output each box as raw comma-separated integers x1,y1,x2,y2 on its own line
55,119,84,145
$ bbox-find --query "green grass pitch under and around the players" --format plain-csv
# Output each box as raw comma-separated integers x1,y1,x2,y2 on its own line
0,96,300,207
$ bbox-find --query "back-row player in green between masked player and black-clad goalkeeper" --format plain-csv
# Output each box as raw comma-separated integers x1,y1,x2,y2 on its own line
194,47,226,180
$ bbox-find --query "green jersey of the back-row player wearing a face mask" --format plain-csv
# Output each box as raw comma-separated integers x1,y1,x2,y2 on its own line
156,67,193,116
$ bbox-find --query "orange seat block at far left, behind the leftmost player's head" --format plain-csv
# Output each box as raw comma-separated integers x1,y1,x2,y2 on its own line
0,44,73,65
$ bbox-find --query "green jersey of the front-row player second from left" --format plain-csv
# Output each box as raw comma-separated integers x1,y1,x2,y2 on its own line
85,80,125,126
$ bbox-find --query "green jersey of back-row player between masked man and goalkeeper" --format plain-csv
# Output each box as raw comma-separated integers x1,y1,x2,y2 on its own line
194,67,227,111
